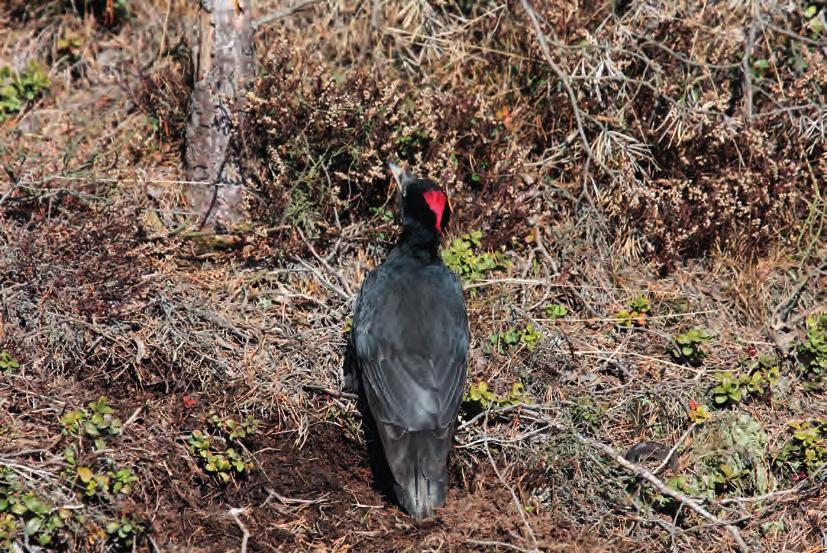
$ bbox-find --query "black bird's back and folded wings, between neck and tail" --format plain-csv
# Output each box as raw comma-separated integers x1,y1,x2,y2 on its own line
353,266,469,431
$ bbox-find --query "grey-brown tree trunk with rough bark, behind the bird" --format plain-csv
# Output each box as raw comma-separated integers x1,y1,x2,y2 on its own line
186,0,255,228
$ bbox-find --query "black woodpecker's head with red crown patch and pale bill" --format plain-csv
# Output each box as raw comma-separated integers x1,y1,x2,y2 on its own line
389,163,451,239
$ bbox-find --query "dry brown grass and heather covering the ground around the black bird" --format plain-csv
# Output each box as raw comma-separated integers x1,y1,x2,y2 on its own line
0,0,827,551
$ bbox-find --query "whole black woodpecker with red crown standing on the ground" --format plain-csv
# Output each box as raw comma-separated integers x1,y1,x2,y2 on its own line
352,164,469,518
